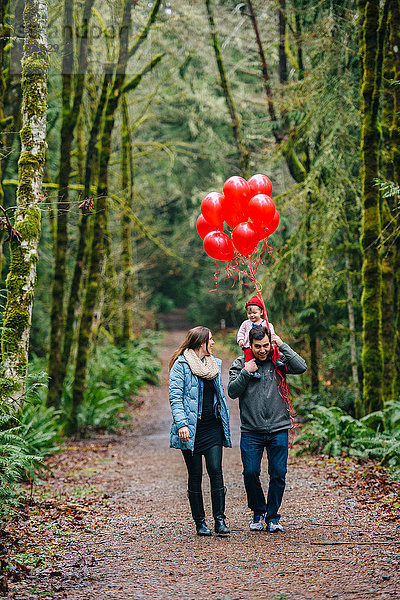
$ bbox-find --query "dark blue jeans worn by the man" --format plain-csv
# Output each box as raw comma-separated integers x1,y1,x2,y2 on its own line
240,429,288,523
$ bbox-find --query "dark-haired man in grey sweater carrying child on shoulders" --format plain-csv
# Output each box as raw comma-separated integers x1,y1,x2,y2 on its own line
228,327,307,533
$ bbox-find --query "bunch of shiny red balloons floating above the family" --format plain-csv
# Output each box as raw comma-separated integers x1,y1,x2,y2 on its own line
196,174,279,261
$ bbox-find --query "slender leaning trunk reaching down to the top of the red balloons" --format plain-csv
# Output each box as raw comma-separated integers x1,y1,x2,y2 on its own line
205,0,250,179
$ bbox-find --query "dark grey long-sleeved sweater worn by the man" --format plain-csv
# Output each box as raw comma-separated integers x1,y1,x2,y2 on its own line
228,343,307,433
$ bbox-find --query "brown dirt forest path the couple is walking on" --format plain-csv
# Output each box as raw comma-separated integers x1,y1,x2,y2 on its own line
10,316,400,600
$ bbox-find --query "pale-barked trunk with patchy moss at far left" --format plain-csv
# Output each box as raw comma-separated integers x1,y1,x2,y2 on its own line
2,0,48,398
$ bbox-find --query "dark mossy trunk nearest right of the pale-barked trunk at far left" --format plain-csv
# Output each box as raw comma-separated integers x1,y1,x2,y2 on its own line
47,0,94,406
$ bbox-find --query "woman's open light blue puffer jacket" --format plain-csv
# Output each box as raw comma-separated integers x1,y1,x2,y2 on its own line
169,354,232,450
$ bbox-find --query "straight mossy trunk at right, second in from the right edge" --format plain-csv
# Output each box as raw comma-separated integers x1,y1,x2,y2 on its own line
359,0,383,413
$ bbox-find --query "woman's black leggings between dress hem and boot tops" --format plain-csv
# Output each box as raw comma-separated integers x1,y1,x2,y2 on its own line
182,445,224,492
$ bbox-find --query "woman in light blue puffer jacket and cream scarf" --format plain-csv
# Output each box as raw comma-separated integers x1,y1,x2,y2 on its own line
169,327,232,535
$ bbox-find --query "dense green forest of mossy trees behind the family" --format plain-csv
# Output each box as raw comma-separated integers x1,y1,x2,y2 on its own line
0,0,400,488
